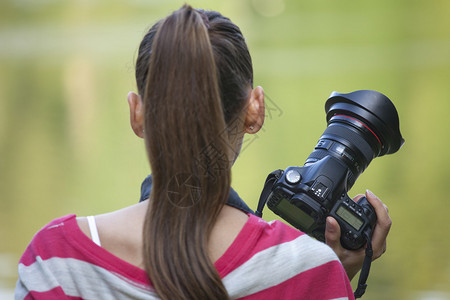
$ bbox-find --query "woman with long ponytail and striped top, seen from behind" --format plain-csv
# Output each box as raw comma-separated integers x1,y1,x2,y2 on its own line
16,6,390,299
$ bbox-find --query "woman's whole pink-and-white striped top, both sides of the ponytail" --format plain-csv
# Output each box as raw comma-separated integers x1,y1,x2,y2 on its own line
15,215,354,300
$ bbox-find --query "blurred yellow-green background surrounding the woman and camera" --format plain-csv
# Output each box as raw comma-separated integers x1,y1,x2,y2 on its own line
0,0,450,300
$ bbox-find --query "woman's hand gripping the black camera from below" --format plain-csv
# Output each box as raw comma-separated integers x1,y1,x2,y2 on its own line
325,190,392,280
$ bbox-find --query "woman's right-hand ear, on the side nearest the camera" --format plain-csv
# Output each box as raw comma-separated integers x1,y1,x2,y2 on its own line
244,86,266,134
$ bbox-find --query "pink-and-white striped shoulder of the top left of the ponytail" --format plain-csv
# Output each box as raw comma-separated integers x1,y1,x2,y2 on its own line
16,211,156,299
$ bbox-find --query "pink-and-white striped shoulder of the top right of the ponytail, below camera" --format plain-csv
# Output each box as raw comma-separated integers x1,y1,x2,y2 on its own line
223,216,351,299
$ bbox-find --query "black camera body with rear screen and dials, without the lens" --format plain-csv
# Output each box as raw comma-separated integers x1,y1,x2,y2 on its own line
267,157,377,249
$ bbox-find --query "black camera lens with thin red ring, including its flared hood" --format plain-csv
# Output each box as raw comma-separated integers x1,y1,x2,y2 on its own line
305,90,404,189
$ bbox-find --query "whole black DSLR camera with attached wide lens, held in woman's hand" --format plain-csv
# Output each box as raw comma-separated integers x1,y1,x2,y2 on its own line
256,90,404,250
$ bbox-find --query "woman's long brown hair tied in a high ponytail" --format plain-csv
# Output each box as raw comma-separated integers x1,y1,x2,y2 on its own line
136,5,253,299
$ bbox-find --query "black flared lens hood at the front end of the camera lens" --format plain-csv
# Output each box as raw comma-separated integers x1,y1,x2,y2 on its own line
325,90,405,156
